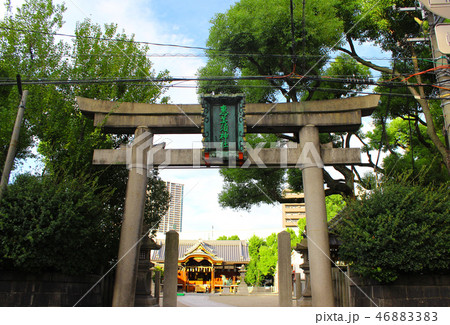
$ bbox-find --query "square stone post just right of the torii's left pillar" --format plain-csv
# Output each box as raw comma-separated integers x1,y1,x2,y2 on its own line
163,230,179,307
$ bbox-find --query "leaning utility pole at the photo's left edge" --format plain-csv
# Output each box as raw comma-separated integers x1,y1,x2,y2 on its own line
0,75,28,199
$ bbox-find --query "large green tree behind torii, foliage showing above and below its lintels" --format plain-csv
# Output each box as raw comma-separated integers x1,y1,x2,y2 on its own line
199,0,370,210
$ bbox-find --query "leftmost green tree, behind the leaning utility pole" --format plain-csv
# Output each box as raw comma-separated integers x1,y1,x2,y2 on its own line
0,0,68,175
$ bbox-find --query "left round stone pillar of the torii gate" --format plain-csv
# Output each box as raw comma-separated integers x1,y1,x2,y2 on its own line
112,127,153,307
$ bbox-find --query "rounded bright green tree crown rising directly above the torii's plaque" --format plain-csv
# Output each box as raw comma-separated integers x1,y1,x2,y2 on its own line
200,0,342,102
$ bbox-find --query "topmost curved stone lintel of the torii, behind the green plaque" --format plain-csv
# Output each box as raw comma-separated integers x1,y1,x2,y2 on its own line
76,95,380,134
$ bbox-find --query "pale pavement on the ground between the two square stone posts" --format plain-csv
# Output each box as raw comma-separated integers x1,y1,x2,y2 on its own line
171,293,294,307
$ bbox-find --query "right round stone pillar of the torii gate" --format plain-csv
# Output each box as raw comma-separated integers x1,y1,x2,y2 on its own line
300,125,334,307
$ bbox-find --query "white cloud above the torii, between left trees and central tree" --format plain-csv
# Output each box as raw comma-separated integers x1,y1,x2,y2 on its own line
59,0,205,104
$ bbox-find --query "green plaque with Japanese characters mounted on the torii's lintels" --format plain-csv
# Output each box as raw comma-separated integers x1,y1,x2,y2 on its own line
202,95,246,161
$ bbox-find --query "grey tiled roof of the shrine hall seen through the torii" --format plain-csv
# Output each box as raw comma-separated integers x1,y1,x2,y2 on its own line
151,239,250,263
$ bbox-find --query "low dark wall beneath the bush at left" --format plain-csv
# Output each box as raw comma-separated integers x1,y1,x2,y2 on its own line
0,271,113,307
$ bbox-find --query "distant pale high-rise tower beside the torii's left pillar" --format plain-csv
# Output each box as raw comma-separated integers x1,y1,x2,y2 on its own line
158,182,184,233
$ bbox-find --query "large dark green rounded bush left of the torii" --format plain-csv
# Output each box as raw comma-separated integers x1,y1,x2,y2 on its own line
0,175,118,274
